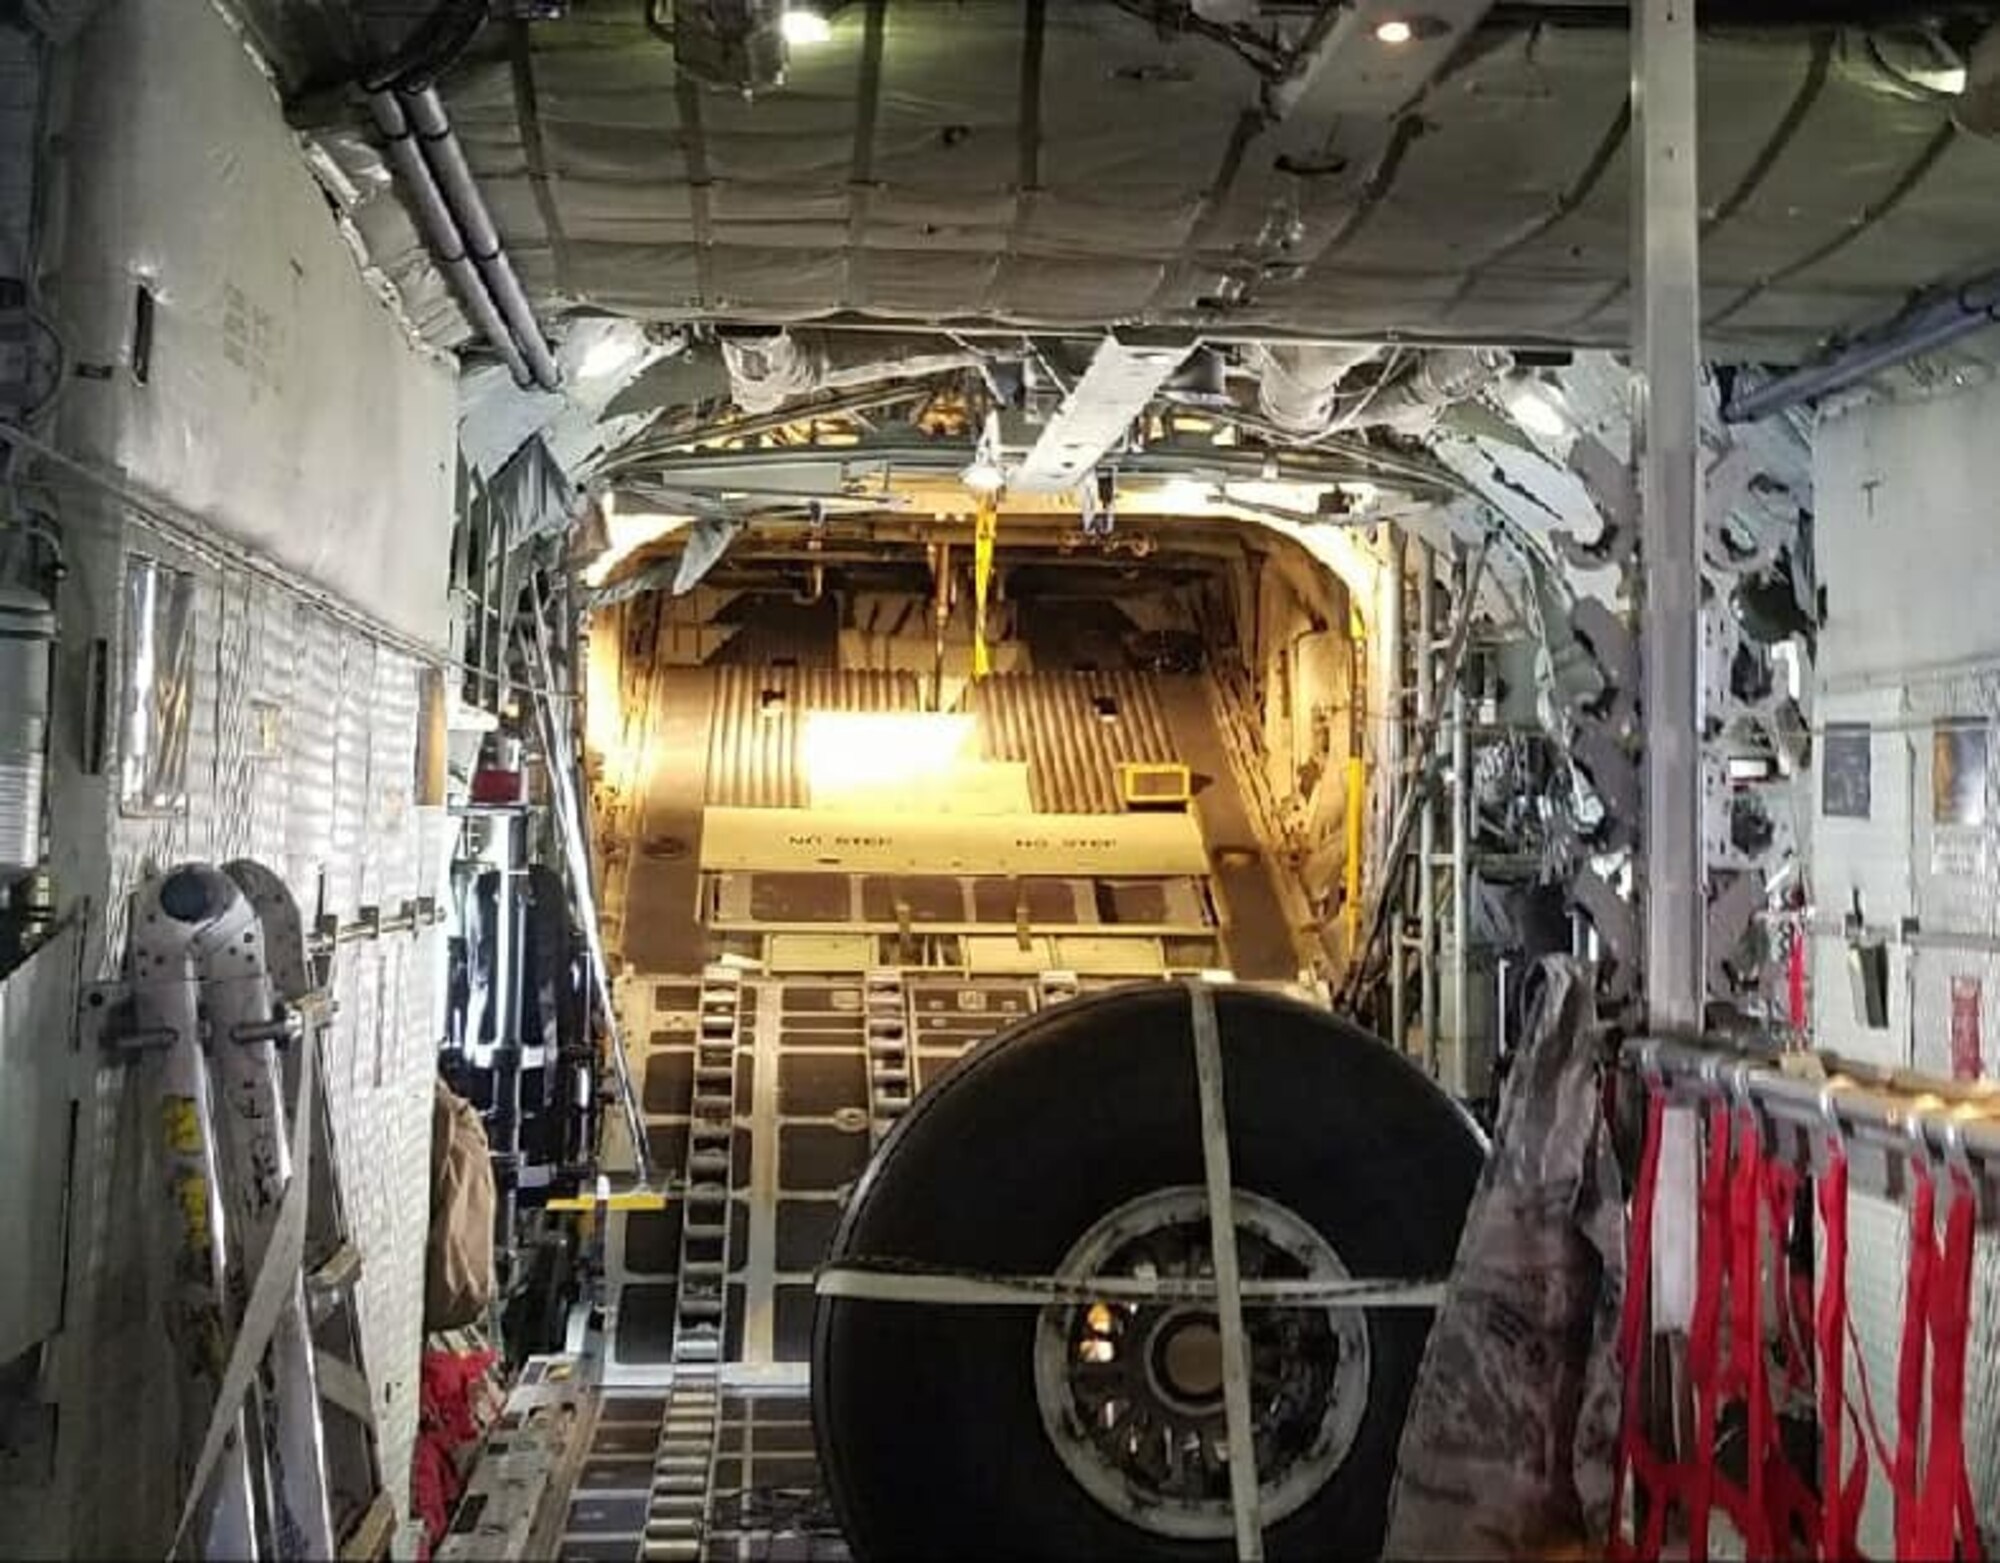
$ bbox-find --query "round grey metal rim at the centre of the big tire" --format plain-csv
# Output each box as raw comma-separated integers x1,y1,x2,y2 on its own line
1034,1187,1368,1539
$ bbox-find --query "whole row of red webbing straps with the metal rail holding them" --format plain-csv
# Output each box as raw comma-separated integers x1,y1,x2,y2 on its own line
1610,1043,1992,1559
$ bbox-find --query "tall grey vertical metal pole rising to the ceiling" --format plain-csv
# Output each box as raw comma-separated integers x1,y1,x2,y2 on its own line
1632,0,1706,1035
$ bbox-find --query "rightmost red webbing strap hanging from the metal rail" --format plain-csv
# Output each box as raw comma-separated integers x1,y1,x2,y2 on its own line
1908,1171,1980,1559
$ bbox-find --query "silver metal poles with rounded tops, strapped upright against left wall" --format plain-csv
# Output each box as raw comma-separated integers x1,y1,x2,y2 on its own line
82,859,394,1559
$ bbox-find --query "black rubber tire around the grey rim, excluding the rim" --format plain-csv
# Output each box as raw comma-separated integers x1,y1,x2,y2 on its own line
812,983,1484,1563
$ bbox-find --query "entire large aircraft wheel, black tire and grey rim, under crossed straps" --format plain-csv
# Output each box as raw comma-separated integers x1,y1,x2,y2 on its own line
812,983,1484,1563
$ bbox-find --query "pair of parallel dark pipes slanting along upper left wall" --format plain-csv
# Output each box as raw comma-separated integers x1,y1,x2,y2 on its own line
368,86,562,392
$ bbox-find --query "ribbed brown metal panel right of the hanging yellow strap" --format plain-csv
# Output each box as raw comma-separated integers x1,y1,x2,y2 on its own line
968,674,1174,813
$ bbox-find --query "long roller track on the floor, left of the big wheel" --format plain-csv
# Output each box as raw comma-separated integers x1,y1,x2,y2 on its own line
642,965,742,1563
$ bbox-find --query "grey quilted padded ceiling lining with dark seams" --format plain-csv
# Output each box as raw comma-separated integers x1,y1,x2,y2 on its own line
398,0,2000,358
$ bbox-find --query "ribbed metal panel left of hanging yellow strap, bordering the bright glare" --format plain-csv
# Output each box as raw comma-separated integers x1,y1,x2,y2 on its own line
708,668,922,809
